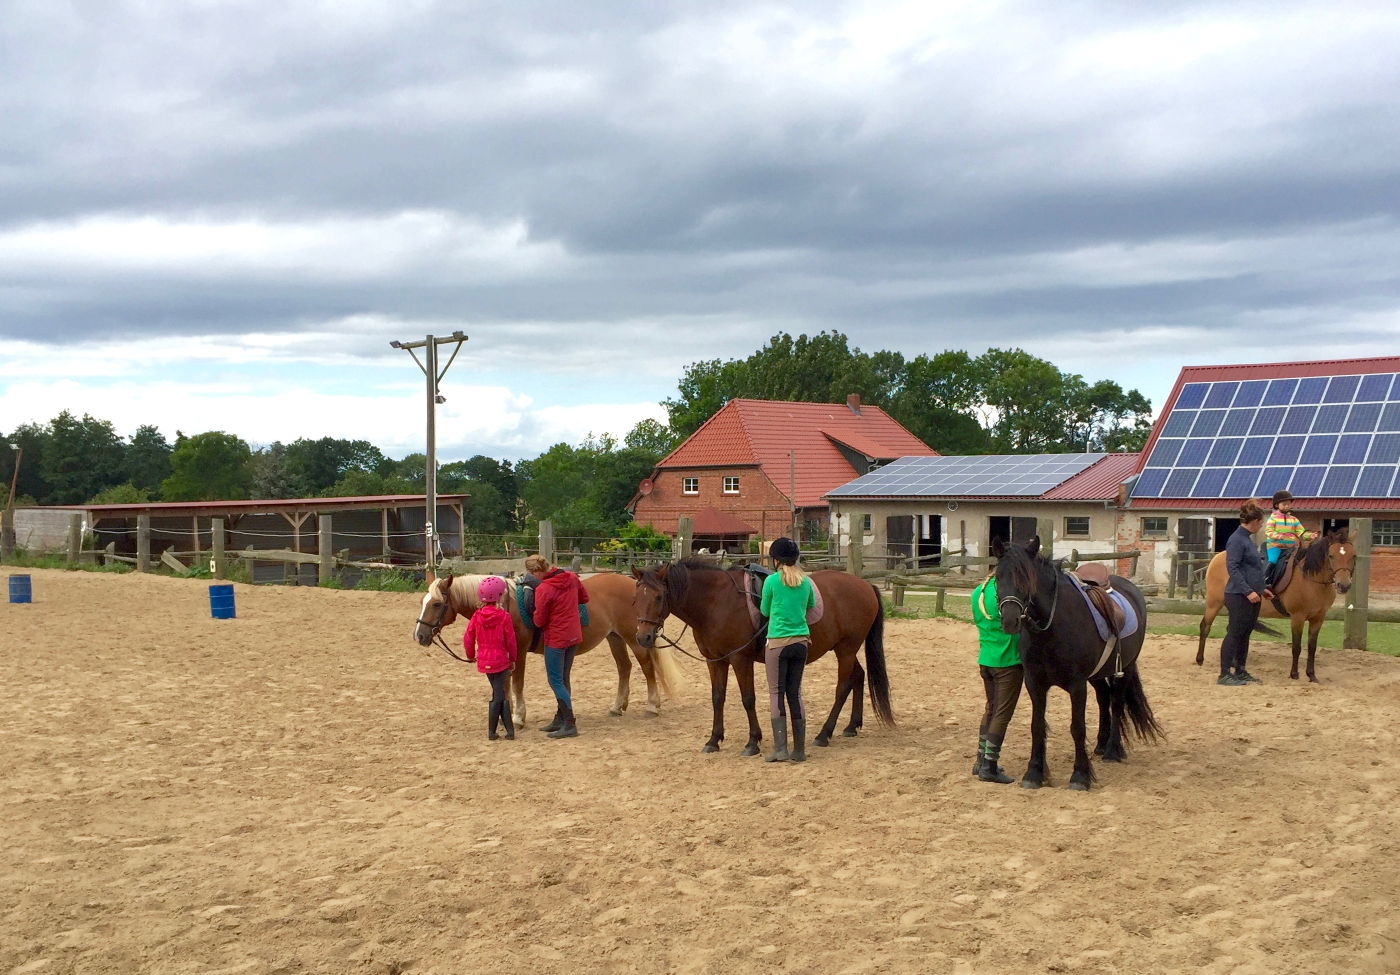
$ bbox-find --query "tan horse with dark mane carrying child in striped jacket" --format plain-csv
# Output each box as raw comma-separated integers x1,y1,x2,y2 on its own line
1196,531,1357,684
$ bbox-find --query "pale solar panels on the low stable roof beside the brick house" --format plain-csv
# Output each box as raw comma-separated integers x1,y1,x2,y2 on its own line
830,454,1107,497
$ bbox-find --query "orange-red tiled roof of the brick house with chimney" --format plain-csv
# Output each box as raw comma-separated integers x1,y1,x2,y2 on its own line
657,399,938,507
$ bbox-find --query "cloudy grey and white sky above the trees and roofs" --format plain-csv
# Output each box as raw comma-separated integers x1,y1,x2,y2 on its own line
0,0,1400,459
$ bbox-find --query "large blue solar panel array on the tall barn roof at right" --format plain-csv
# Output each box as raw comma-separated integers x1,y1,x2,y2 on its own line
1133,373,1400,499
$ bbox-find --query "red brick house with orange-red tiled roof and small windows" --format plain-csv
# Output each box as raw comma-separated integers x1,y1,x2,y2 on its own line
629,395,937,551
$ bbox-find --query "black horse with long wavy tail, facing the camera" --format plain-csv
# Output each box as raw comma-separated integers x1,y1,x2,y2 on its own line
991,538,1162,791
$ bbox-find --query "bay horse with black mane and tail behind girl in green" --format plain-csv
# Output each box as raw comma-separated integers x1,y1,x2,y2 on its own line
631,560,895,755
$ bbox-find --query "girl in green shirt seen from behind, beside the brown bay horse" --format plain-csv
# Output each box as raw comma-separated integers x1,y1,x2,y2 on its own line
759,538,816,762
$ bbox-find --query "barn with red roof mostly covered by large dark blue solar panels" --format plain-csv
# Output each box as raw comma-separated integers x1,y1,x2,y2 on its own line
1124,356,1400,595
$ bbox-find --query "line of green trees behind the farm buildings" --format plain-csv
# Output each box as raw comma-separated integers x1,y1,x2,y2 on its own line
0,332,1151,541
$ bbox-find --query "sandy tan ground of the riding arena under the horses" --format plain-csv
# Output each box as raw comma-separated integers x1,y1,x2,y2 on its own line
0,570,1400,975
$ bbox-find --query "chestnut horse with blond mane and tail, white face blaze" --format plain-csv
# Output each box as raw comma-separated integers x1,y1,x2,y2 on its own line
413,572,680,724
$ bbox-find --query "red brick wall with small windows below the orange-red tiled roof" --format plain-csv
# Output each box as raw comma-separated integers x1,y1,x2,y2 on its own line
633,468,792,538
